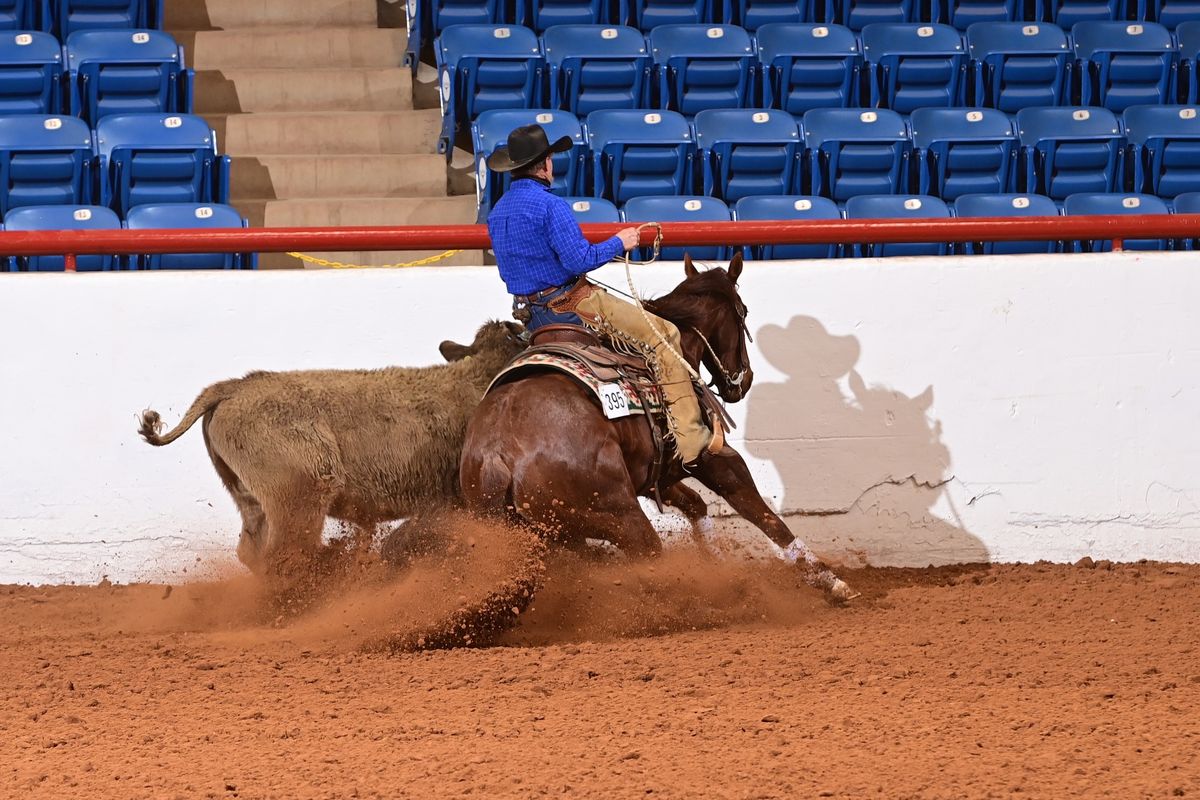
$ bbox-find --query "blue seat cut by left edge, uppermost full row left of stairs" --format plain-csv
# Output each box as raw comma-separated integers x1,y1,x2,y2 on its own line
0,31,62,114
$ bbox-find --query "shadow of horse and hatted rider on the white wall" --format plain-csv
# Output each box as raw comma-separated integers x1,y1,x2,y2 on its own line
745,317,989,566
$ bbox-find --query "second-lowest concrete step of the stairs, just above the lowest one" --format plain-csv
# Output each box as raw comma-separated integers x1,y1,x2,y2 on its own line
230,155,446,200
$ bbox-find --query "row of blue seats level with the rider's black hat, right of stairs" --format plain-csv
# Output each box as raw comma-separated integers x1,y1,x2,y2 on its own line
474,106,1200,218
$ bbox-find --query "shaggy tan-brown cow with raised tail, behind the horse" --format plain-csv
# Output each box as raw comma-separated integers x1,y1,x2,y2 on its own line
139,321,524,572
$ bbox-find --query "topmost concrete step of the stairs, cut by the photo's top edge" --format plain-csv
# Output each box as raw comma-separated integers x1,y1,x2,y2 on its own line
166,0,379,30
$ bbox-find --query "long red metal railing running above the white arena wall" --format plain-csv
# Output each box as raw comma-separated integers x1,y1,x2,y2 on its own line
0,213,1200,271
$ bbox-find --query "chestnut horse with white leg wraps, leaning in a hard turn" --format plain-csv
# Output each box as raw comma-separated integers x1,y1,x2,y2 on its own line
460,254,850,597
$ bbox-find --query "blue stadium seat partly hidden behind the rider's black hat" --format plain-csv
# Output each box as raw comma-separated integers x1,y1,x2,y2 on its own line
470,109,587,222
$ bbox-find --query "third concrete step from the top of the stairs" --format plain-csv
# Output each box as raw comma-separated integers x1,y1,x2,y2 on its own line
196,67,413,114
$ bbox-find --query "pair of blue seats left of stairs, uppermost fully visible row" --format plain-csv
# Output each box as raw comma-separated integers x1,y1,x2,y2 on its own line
0,30,194,125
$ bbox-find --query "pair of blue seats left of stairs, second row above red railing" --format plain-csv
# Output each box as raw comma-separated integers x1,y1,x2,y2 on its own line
0,114,230,223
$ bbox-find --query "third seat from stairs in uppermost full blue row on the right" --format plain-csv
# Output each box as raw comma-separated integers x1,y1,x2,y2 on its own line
649,25,755,116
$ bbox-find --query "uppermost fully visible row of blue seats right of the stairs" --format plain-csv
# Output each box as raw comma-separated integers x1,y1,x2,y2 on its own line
438,19,1200,152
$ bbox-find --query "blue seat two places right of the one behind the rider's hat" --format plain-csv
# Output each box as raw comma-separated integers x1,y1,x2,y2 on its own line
695,108,802,203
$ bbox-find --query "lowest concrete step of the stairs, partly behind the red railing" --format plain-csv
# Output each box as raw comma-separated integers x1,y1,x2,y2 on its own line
236,197,484,269
